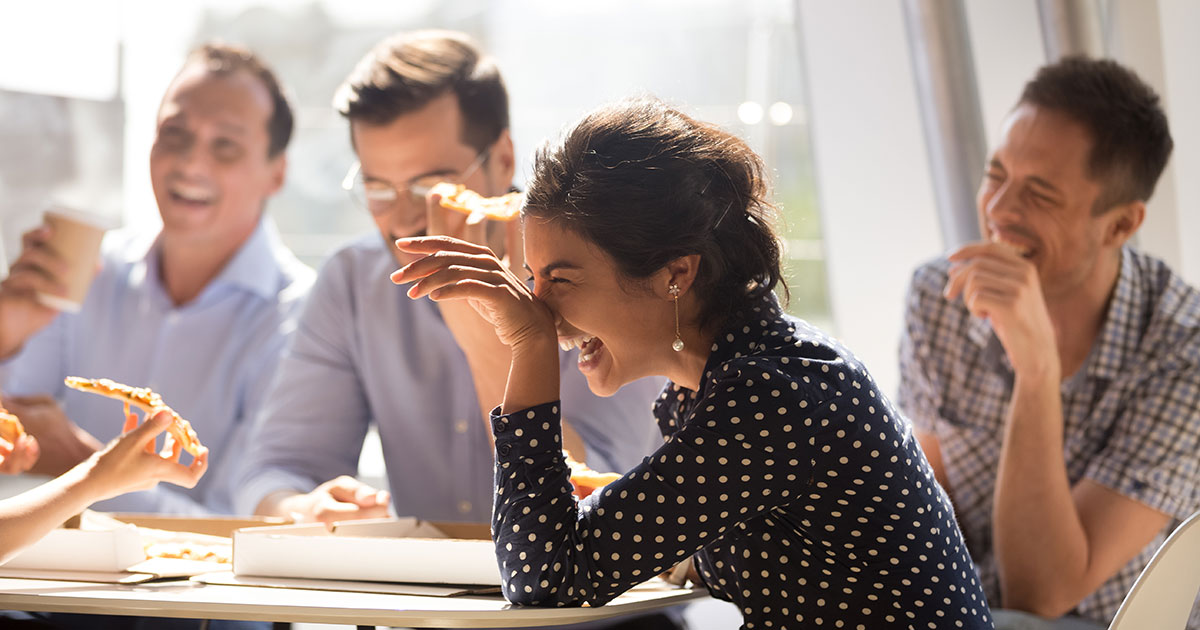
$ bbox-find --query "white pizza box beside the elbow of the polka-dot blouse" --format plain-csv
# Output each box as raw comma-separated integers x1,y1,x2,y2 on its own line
233,517,500,594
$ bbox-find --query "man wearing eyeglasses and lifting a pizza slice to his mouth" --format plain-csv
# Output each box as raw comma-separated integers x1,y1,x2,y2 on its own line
238,31,661,559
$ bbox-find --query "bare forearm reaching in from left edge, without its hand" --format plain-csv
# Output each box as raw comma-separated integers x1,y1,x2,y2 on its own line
0,466,101,562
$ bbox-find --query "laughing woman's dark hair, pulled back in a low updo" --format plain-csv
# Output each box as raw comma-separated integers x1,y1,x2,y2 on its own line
523,97,786,328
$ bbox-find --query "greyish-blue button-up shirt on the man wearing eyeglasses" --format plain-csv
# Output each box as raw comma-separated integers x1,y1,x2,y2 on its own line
234,234,664,522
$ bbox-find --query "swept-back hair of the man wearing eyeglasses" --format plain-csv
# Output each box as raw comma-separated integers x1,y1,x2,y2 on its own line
334,30,509,151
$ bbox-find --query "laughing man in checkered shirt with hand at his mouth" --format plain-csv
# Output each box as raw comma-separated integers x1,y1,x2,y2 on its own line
899,58,1200,629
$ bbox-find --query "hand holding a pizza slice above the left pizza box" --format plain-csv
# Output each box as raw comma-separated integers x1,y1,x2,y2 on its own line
80,410,209,500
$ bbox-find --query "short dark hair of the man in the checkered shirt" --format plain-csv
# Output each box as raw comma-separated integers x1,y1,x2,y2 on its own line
1018,56,1175,214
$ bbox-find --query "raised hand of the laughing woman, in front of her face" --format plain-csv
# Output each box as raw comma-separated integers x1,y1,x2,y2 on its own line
391,236,558,348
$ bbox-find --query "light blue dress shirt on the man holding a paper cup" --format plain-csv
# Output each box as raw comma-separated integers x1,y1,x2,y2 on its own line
0,218,314,515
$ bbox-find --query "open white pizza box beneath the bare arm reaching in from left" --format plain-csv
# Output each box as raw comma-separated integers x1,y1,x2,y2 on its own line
0,510,287,583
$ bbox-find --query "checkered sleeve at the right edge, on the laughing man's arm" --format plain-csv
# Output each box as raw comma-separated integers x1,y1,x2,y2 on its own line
1085,365,1200,520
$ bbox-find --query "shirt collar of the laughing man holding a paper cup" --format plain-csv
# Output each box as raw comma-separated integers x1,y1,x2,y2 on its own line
135,214,284,299
